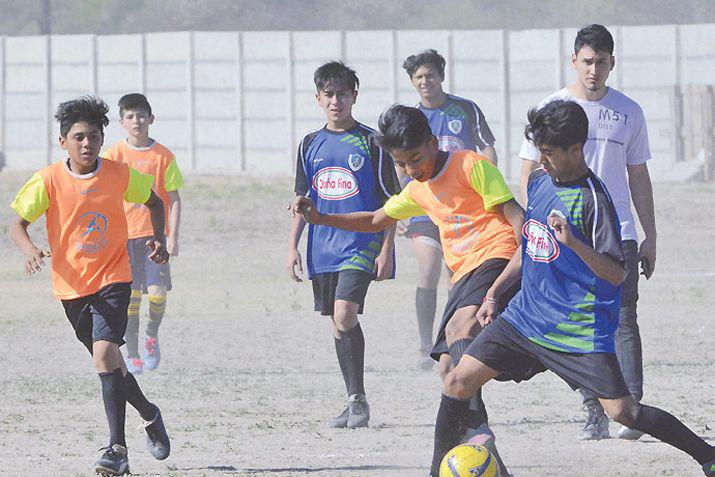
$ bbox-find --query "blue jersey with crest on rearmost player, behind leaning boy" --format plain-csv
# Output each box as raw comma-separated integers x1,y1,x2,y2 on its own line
410,94,494,226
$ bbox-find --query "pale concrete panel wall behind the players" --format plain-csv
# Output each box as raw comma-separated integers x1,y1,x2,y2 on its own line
0,25,715,179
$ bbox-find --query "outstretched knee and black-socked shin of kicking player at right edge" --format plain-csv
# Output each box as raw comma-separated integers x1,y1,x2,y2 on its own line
600,396,715,468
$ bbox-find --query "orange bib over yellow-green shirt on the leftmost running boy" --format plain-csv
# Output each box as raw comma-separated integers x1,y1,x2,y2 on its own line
10,158,152,300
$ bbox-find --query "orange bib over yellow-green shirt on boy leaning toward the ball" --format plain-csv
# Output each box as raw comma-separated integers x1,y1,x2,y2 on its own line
384,151,517,283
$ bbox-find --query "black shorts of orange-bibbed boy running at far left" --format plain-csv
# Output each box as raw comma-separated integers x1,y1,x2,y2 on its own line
62,283,132,354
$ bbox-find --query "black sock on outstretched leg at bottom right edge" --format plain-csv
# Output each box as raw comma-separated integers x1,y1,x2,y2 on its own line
633,404,715,465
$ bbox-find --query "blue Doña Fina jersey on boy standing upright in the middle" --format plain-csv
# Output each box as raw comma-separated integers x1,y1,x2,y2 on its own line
295,123,400,278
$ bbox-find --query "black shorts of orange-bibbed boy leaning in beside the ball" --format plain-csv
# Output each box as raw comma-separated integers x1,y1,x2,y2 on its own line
430,258,520,361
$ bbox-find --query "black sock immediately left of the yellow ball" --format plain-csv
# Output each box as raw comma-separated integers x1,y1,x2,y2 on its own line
431,394,469,477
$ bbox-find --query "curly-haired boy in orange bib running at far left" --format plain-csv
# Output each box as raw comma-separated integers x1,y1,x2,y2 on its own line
10,96,170,475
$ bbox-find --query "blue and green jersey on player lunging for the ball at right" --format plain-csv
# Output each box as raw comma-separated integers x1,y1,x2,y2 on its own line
502,169,624,353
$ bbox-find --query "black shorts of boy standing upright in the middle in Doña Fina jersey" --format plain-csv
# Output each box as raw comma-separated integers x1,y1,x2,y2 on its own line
310,270,375,316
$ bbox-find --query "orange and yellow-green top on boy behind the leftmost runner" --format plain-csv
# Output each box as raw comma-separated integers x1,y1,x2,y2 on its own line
102,140,184,239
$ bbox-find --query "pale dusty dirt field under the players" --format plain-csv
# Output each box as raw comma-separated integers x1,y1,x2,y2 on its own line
0,172,715,477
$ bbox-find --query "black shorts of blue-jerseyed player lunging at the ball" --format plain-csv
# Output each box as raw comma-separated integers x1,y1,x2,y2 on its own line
466,319,630,399
